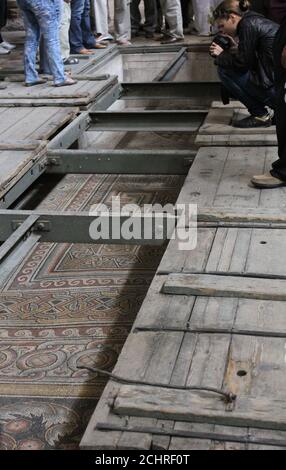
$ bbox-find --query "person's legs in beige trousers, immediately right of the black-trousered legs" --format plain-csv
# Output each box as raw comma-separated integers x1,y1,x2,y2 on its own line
160,0,184,44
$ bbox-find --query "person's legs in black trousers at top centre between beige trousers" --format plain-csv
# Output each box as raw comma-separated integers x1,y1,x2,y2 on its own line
130,0,157,39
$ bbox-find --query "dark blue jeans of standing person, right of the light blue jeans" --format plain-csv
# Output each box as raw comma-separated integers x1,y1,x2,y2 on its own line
70,0,96,54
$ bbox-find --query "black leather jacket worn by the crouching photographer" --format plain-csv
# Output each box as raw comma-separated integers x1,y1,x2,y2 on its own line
215,11,279,88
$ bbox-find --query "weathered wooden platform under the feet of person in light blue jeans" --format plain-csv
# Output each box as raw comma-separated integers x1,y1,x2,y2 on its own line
0,77,117,107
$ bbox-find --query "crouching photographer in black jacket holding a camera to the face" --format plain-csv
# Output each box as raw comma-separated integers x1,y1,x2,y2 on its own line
210,0,279,128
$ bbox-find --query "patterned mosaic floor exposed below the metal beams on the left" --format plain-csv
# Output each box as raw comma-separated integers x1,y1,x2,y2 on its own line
0,175,183,449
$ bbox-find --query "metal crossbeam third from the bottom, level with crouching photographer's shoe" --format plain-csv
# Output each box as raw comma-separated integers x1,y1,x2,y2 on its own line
89,110,207,132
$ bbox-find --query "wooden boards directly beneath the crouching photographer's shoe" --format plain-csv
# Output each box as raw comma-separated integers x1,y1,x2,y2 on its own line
196,102,277,147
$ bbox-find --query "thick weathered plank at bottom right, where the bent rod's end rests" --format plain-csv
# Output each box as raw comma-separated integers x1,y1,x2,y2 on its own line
114,385,286,431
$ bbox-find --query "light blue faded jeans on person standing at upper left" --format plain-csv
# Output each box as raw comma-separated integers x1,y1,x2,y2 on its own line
17,0,66,84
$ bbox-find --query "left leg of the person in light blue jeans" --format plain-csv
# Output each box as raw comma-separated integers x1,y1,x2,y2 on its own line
18,0,40,83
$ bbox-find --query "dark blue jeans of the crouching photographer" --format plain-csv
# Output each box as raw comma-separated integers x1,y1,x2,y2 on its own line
218,67,276,117
